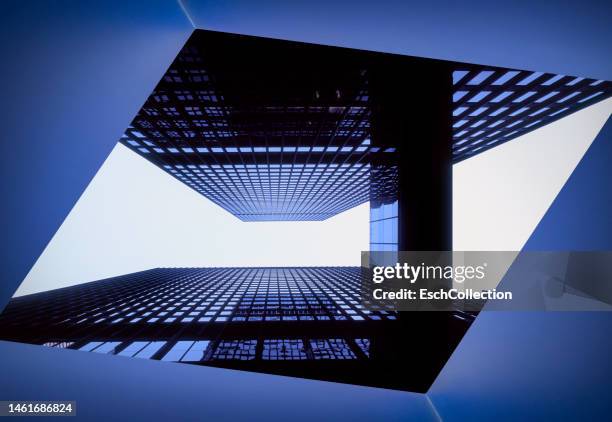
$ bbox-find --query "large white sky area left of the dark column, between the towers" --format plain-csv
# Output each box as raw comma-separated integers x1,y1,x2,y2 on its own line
15,144,369,296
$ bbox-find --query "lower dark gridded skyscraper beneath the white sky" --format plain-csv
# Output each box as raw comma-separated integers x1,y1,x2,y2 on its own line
0,267,469,391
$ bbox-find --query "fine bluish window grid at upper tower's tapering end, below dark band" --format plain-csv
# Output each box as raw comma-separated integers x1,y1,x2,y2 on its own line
164,163,370,221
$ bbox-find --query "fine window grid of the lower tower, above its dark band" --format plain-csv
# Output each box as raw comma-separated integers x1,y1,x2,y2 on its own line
0,267,397,330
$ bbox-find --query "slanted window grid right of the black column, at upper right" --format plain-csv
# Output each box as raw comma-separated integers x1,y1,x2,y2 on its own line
453,67,612,162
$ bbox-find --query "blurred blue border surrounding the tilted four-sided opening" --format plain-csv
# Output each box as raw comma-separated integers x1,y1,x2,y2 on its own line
0,0,612,420
